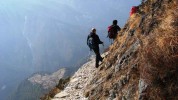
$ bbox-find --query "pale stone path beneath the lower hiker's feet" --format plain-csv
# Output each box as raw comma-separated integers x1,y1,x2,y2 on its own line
52,56,101,100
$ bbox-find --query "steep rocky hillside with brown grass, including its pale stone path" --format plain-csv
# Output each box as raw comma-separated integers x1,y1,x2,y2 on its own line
51,0,178,100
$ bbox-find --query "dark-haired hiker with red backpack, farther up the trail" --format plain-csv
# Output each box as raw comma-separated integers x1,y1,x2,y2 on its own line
107,20,121,40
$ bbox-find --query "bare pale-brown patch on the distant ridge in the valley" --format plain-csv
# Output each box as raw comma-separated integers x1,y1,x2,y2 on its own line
28,68,66,89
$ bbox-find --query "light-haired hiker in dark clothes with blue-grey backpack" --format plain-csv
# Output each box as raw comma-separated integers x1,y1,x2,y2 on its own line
87,28,103,68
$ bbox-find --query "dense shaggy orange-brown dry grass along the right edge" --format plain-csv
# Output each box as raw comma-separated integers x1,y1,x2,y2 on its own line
137,2,178,100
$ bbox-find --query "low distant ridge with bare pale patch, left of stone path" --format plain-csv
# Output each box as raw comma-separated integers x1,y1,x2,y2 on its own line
7,68,71,100
